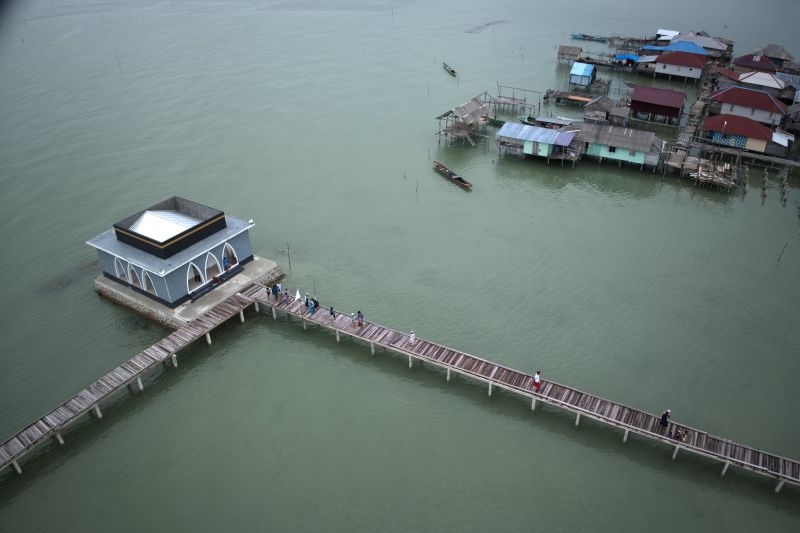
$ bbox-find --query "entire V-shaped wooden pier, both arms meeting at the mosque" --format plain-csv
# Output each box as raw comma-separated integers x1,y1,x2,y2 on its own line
0,283,800,493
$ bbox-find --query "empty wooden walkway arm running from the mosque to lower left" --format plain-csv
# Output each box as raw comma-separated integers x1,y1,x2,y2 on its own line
0,294,253,473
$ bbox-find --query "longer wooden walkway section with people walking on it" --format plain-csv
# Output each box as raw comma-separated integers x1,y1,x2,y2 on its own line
242,286,800,492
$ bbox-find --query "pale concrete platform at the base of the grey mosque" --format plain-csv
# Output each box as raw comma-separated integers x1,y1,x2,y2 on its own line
94,255,283,329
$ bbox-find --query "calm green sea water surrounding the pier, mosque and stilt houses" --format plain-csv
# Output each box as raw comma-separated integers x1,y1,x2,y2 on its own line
0,0,800,532
